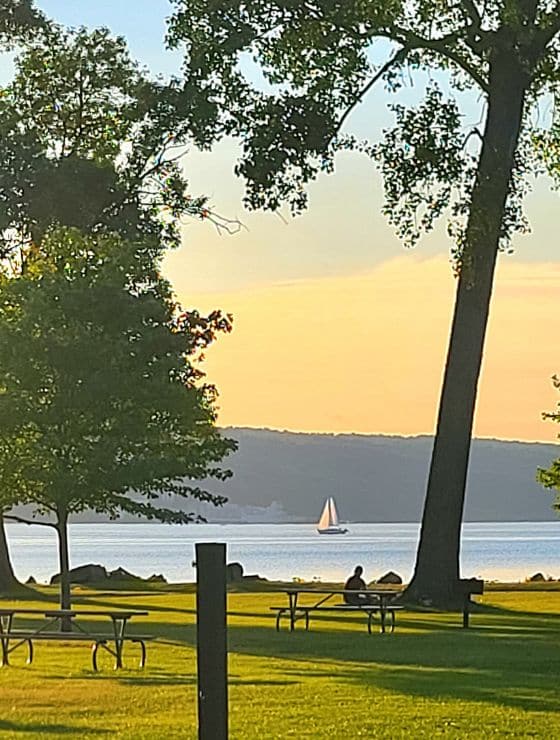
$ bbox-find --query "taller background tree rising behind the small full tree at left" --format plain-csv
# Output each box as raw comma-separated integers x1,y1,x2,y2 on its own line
0,20,236,589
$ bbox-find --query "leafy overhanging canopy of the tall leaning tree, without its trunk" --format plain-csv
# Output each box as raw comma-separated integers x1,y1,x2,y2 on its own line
168,0,560,251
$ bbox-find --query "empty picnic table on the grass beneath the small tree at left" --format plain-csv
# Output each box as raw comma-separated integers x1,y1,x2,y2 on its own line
0,607,152,671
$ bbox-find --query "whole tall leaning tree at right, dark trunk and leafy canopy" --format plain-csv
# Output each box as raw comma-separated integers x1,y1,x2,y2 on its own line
169,0,560,606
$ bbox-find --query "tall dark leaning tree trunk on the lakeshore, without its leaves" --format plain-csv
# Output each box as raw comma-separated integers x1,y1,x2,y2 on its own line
404,51,526,607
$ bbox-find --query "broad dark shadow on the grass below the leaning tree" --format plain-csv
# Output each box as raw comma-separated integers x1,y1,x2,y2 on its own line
111,610,560,712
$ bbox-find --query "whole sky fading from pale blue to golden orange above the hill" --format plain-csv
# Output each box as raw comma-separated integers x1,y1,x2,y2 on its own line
15,0,560,442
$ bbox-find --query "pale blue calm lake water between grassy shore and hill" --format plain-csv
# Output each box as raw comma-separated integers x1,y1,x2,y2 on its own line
7,521,560,583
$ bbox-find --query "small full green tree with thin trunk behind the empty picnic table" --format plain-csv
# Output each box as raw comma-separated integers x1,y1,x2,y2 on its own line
0,228,236,608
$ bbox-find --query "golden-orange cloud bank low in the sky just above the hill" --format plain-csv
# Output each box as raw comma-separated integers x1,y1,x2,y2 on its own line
179,255,560,441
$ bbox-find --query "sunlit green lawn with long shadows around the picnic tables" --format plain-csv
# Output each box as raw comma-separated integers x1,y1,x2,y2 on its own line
0,588,560,740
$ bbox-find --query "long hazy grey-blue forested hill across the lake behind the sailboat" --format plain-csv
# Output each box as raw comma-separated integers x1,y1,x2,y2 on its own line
196,428,560,522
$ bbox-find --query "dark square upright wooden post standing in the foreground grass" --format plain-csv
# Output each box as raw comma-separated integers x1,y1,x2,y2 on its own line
196,543,228,740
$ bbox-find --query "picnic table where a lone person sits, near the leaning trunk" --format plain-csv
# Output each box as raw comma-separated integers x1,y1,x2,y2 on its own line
270,586,403,634
